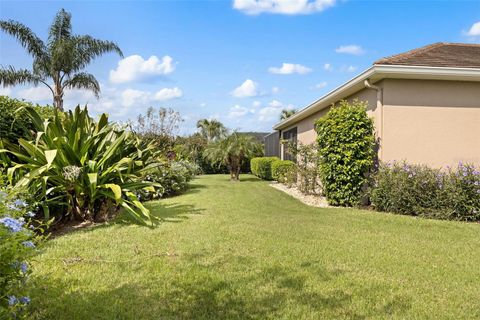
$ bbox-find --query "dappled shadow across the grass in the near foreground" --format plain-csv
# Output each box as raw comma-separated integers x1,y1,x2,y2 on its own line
32,259,410,319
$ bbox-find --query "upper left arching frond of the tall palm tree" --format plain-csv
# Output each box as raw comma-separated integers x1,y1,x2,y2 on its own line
0,20,47,58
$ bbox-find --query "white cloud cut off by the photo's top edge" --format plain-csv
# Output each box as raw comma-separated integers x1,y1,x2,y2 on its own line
233,0,336,15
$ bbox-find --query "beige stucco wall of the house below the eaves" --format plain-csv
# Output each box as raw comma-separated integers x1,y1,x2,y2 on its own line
280,79,480,167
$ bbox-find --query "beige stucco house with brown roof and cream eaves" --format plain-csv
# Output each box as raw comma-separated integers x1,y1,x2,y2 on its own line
274,43,480,167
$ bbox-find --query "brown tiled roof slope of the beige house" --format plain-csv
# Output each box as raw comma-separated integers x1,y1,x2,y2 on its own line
373,42,480,68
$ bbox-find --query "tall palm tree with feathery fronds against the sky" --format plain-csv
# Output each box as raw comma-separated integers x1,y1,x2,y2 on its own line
0,9,123,110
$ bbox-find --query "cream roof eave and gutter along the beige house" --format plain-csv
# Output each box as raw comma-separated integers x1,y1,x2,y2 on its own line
273,64,480,130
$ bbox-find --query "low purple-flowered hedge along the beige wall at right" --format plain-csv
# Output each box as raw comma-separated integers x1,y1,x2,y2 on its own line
370,162,480,221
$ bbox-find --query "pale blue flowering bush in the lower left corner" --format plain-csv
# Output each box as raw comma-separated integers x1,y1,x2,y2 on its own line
0,189,45,319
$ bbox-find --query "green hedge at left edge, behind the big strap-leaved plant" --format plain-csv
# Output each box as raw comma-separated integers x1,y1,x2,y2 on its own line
0,96,53,143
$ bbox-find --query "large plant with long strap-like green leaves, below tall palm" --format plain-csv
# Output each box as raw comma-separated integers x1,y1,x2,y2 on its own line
0,106,159,223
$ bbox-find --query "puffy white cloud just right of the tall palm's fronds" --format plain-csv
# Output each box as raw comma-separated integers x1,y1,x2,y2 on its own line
110,55,175,83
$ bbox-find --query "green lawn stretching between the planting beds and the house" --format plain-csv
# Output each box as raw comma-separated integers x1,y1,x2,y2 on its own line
31,176,480,319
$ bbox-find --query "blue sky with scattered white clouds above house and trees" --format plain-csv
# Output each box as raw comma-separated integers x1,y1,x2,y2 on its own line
0,0,480,134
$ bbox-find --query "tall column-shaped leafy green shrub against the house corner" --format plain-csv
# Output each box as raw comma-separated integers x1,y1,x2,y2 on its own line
316,100,375,206
